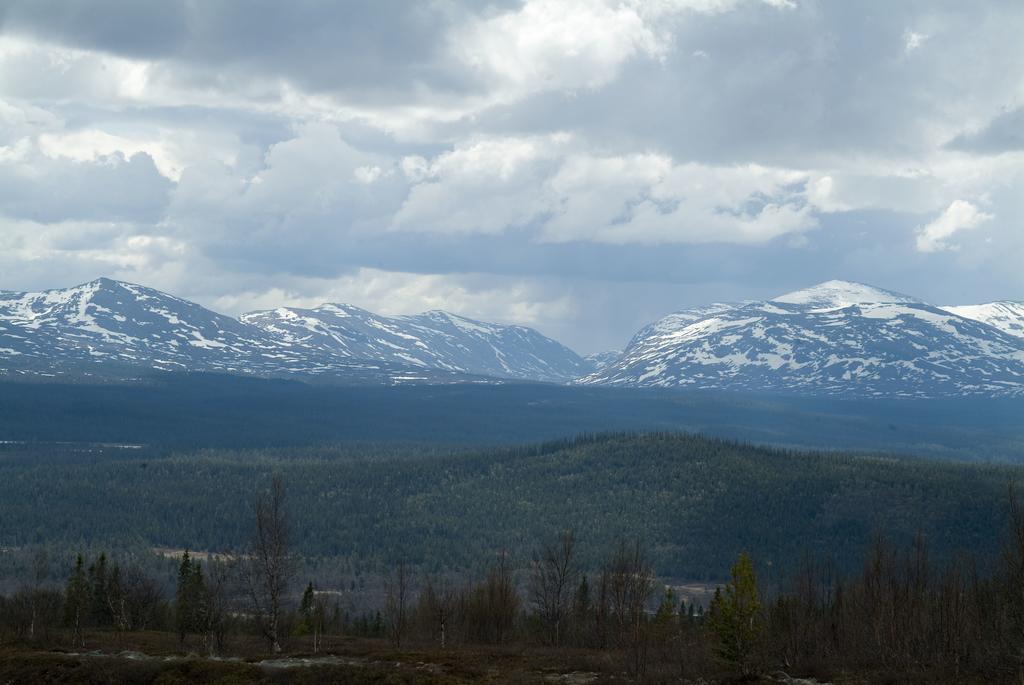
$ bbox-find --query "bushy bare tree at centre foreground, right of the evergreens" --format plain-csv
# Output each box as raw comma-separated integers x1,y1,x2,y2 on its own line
529,530,580,646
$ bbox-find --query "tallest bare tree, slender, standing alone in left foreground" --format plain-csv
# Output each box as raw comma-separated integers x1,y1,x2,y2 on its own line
242,475,295,653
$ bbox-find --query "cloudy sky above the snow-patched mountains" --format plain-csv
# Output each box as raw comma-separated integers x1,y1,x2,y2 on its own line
0,0,1024,353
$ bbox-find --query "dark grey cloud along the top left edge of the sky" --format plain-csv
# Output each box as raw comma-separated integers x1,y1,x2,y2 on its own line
0,0,495,99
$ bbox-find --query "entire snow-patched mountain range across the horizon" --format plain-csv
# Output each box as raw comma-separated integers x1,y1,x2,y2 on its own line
0,279,1024,397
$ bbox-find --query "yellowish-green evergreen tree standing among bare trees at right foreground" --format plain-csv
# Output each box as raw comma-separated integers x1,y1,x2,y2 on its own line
709,552,763,676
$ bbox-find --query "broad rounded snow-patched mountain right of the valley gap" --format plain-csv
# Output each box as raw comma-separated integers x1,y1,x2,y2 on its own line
578,281,1024,396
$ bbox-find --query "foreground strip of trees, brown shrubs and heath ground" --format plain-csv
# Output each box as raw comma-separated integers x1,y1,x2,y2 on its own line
0,493,1024,683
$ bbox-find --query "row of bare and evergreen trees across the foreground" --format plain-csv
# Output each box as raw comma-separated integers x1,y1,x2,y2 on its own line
6,477,1024,681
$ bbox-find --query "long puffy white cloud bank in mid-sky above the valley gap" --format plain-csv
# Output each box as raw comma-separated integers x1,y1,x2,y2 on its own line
391,135,817,245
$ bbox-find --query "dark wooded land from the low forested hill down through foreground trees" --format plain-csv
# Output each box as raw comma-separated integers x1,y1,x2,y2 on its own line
0,433,1024,682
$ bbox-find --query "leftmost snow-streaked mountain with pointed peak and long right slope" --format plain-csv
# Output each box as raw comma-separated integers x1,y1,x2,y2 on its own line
0,277,579,383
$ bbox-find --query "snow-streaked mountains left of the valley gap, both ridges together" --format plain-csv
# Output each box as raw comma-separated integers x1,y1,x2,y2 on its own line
0,279,583,383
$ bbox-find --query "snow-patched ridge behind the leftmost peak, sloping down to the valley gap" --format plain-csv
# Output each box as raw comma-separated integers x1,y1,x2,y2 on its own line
242,304,589,382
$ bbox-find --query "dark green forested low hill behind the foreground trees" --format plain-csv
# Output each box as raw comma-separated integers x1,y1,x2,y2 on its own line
0,433,1021,581
